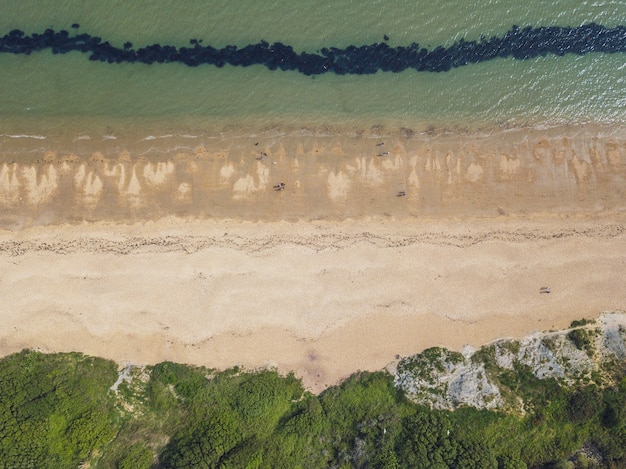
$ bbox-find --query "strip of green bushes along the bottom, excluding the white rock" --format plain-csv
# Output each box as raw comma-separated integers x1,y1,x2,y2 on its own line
0,347,626,469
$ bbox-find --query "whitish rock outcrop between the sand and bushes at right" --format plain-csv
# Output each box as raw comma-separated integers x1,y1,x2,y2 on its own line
395,311,626,410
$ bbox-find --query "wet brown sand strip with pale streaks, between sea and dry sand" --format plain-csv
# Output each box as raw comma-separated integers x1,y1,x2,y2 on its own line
0,122,626,230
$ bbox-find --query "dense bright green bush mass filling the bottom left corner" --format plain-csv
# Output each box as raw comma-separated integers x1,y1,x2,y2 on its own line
0,351,117,469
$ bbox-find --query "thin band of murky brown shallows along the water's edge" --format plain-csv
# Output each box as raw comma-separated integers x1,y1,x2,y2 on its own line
0,120,626,154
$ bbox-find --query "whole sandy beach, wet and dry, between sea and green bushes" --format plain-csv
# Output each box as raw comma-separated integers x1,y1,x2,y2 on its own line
0,125,626,391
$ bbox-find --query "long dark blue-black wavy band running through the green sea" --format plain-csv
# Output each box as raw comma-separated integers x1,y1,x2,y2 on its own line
0,23,626,75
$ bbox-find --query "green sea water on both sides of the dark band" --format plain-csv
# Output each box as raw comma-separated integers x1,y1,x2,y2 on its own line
0,0,626,135
